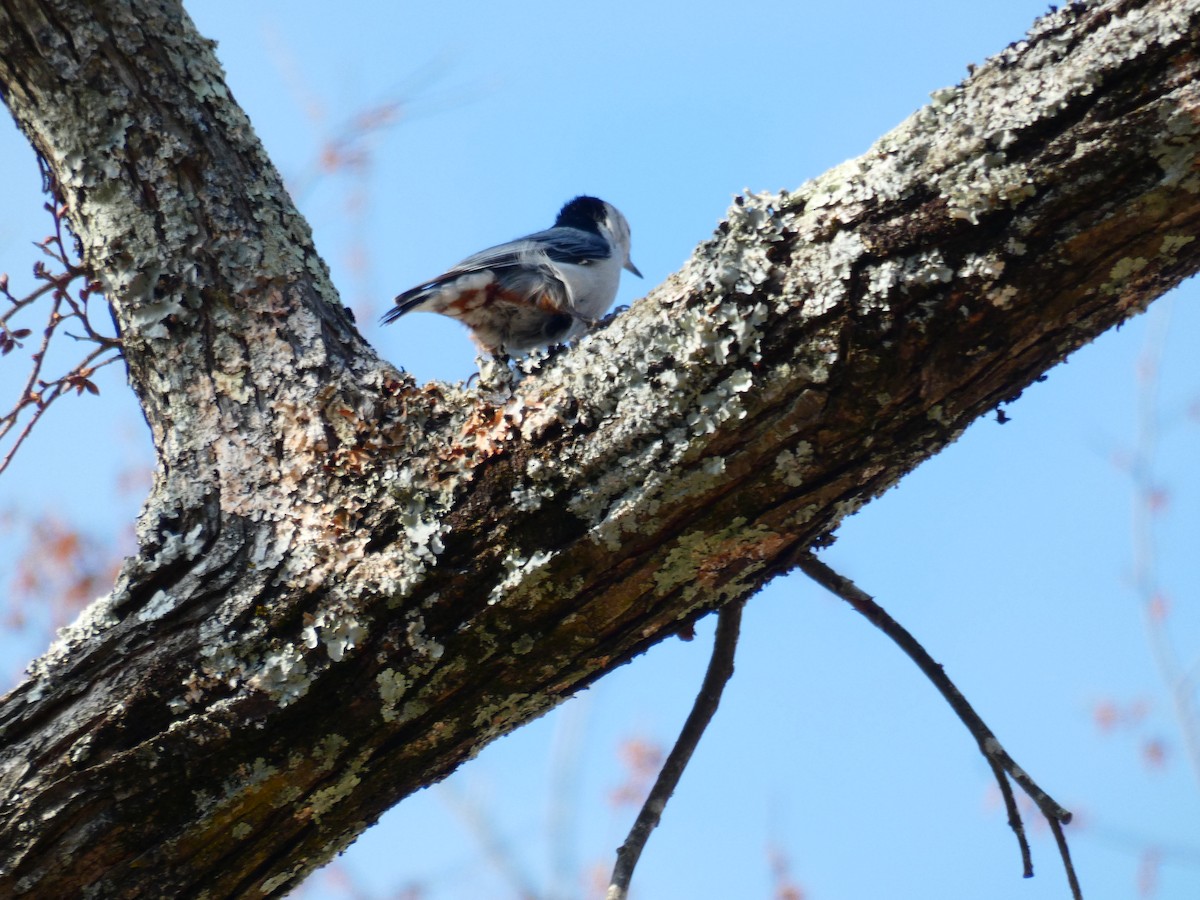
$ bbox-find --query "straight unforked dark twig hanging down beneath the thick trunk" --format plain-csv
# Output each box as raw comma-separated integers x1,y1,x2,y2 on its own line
605,600,745,900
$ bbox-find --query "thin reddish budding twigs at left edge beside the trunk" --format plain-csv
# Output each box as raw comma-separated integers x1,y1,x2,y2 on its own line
0,166,120,473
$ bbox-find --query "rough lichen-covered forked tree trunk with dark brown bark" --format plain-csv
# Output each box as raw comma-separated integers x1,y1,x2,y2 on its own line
0,0,1200,898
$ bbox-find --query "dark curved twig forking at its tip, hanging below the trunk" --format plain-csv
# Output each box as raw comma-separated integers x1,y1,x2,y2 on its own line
796,552,1082,900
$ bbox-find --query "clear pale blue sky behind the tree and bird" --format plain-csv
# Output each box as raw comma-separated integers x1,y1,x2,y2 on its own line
0,0,1200,900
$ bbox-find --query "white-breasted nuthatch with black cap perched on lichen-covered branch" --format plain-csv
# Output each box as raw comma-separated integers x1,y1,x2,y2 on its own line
383,197,642,355
